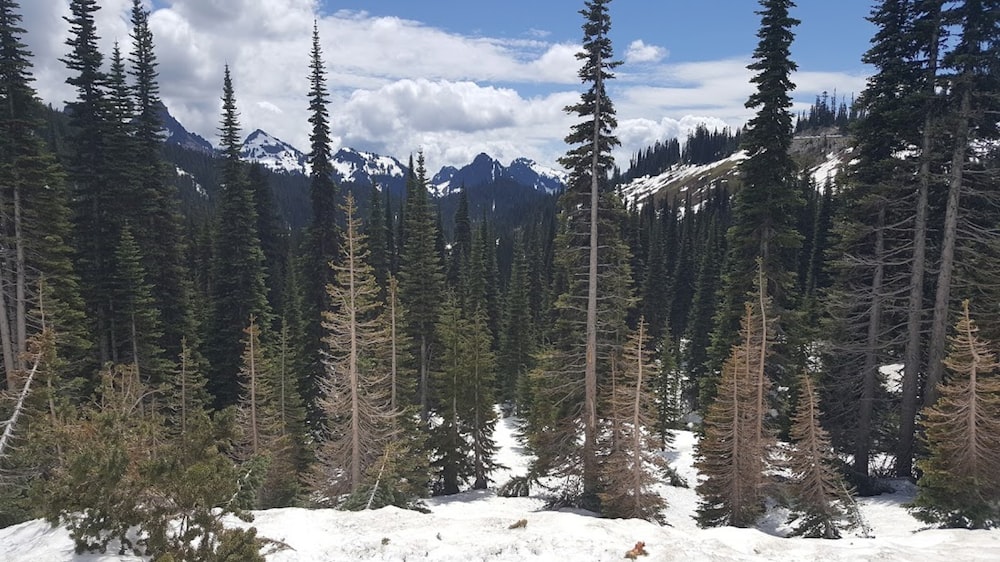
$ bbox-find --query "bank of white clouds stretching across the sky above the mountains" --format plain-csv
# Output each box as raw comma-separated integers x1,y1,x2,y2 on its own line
22,0,864,171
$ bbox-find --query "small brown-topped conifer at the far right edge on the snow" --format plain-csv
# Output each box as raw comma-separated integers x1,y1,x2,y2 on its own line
913,301,1000,529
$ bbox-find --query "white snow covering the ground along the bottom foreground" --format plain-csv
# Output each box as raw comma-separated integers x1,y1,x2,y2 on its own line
0,418,1000,562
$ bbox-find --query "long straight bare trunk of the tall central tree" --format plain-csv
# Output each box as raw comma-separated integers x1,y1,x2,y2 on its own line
583,47,602,496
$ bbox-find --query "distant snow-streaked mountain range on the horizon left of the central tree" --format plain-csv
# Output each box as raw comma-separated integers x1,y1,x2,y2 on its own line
161,107,566,197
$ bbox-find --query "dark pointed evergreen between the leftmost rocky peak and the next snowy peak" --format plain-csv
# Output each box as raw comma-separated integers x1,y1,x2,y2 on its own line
206,66,271,406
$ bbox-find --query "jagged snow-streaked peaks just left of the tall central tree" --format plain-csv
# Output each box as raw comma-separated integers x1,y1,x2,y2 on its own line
430,153,566,197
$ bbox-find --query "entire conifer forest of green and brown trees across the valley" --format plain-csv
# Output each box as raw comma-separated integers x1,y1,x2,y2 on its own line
0,0,1000,560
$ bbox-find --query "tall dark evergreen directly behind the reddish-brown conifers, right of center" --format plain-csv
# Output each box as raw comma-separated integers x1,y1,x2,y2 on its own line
710,0,802,402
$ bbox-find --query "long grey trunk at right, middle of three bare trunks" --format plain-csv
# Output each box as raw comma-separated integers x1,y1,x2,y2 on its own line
895,19,939,478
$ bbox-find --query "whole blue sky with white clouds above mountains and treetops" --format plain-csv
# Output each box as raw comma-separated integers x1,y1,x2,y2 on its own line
21,0,873,171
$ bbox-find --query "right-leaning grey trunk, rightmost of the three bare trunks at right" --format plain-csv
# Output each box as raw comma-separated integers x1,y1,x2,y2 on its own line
924,87,972,406
